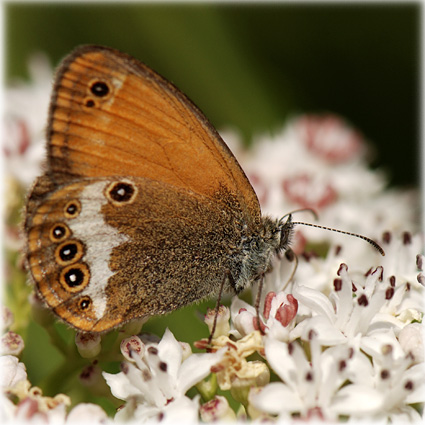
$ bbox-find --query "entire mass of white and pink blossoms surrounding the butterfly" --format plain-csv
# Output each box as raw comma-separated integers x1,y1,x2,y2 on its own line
0,55,425,423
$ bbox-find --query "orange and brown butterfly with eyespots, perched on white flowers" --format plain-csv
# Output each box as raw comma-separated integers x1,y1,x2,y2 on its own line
25,46,292,332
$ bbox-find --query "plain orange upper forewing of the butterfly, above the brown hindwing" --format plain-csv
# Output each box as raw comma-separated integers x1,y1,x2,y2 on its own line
48,46,260,222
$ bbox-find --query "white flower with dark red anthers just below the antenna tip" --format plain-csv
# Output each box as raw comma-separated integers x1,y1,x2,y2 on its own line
293,264,420,345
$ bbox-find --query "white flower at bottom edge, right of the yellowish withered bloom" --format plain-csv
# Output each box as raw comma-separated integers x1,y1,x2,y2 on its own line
250,334,382,421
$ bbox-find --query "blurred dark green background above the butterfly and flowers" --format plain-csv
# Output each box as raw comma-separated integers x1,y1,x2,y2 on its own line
5,2,421,185
